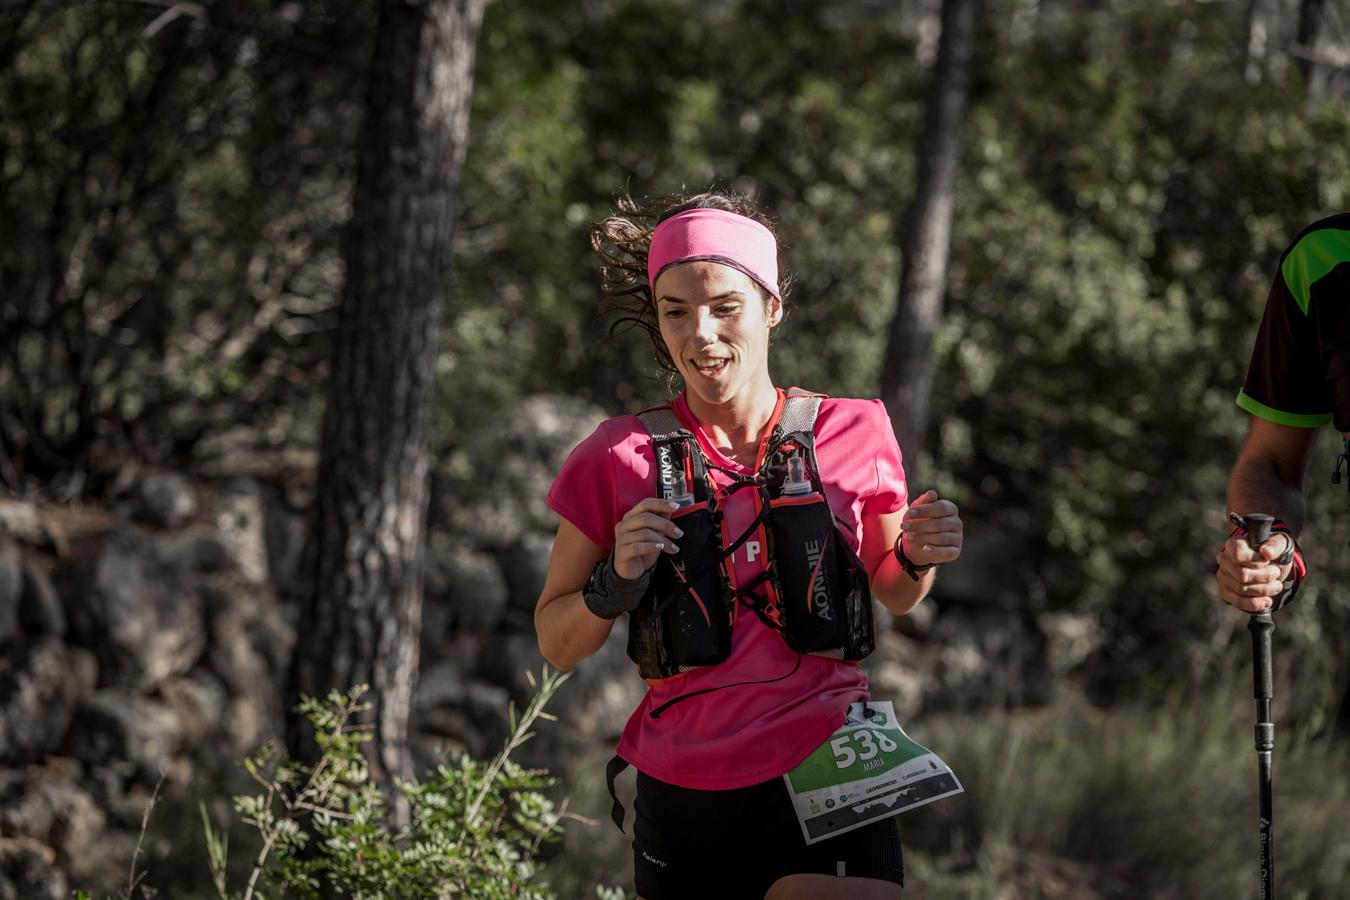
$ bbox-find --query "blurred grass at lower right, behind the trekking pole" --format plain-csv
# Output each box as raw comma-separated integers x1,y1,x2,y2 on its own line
900,679,1350,900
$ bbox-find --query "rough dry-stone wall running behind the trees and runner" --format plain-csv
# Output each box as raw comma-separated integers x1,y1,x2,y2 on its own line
0,397,1092,900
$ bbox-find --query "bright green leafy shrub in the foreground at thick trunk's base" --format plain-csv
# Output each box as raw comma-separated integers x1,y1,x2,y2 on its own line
201,668,568,900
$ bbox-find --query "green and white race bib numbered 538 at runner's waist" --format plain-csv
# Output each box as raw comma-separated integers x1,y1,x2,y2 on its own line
783,700,963,845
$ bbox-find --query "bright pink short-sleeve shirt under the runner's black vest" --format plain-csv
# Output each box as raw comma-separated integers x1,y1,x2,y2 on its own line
548,395,907,791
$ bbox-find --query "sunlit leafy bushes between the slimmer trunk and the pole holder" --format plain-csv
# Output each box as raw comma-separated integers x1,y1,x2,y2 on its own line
933,3,1350,691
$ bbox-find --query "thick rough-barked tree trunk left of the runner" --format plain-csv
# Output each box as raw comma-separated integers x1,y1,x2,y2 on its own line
288,0,485,823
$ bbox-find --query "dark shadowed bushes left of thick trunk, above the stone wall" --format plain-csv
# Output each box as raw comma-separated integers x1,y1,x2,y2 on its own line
0,0,369,495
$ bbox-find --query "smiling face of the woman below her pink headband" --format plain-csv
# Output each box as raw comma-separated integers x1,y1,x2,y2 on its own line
655,260,783,405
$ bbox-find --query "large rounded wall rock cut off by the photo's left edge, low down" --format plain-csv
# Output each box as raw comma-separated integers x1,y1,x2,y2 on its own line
0,638,88,764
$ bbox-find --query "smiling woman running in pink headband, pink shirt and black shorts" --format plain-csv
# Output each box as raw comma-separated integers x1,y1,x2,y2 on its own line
535,186,963,900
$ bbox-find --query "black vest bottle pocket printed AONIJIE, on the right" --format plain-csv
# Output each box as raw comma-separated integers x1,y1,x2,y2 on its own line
768,494,876,660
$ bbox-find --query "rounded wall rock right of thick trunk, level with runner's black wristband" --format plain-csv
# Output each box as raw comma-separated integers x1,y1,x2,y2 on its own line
423,533,507,639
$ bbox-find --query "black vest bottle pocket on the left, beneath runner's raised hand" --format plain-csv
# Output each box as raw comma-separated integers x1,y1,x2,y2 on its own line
628,503,732,679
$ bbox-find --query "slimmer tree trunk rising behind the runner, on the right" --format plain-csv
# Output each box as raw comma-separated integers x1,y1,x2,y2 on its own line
882,0,980,478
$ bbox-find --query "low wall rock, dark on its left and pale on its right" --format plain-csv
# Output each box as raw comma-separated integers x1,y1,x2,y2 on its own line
70,688,182,784
